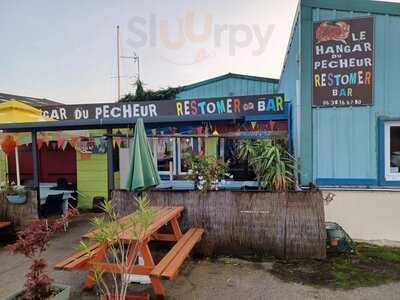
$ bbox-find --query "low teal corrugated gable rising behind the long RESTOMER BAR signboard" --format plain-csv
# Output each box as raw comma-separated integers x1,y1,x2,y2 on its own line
176,77,278,99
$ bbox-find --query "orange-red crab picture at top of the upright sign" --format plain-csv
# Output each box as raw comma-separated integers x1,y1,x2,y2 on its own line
315,21,350,44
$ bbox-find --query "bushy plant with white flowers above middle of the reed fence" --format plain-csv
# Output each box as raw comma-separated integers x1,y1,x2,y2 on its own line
187,155,232,192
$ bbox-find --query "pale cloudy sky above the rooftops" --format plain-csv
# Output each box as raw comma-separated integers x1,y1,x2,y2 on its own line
0,0,400,104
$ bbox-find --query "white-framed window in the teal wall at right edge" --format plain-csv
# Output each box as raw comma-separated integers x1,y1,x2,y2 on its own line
385,121,400,180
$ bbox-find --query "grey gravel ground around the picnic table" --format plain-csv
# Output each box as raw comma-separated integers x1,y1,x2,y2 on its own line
0,218,400,300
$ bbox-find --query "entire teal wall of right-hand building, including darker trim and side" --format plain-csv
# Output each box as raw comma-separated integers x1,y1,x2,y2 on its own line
279,0,400,184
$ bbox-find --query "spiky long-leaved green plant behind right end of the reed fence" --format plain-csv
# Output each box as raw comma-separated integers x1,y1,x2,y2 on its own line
239,139,295,191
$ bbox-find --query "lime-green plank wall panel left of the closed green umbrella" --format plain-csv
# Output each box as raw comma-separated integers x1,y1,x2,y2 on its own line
76,152,108,209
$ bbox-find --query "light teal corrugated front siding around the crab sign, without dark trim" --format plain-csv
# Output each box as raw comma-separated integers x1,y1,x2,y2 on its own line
310,8,400,181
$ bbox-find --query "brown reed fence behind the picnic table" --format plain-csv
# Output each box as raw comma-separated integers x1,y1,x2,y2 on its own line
112,191,326,259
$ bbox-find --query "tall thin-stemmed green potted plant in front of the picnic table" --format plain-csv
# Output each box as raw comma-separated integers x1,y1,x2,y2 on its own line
81,195,154,300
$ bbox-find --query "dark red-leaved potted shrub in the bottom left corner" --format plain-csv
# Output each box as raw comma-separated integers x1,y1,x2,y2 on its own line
5,209,77,300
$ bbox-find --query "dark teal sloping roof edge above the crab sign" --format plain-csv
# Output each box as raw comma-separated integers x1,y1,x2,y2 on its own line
301,0,400,16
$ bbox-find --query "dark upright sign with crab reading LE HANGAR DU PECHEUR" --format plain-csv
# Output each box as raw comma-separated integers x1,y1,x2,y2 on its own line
312,17,374,107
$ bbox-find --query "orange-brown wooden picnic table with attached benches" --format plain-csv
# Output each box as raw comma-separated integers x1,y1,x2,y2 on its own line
55,207,204,297
